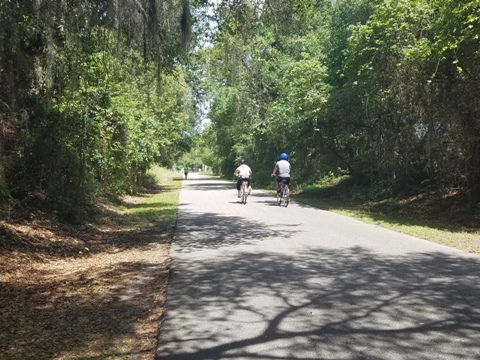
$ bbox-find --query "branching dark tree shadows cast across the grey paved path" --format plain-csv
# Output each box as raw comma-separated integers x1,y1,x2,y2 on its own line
155,210,480,360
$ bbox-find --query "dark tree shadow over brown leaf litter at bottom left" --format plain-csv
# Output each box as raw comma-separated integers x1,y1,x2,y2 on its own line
0,262,168,360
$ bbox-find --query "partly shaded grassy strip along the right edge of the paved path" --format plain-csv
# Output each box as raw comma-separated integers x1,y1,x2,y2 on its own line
292,182,480,254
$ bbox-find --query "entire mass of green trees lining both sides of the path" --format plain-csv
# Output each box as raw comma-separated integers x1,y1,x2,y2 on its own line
0,0,480,218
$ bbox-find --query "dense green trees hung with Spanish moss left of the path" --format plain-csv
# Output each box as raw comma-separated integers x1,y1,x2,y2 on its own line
0,0,194,221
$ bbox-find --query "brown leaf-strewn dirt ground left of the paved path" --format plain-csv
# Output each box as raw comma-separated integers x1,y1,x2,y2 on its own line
0,197,173,360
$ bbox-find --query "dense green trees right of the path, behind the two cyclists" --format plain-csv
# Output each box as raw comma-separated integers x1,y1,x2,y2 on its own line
194,0,480,210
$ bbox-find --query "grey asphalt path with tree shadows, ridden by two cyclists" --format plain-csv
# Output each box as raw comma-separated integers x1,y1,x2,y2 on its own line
155,174,480,360
